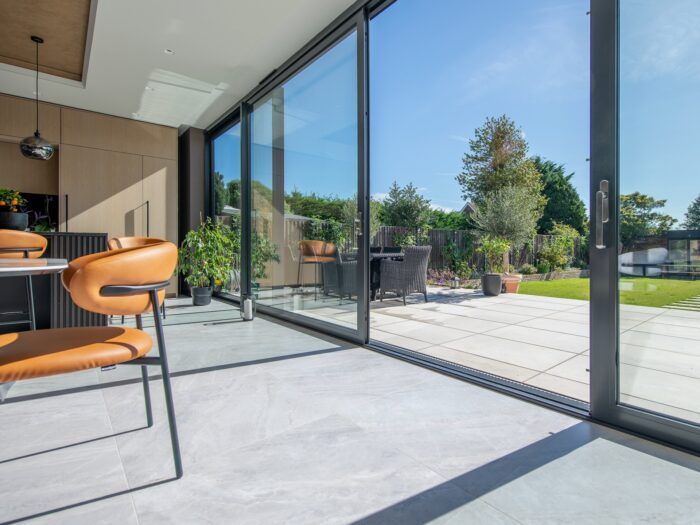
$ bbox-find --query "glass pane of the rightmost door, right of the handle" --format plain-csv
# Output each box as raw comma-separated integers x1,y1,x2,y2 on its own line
619,0,700,423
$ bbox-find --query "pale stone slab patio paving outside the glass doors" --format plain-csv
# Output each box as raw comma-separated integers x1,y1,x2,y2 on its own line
370,287,700,422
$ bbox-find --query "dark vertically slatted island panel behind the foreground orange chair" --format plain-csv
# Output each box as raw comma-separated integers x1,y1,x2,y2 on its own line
44,232,107,328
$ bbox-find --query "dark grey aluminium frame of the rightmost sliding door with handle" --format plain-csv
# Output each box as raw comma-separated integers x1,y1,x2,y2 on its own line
590,0,700,452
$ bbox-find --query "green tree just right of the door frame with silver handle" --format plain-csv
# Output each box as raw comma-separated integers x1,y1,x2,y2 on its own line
620,191,677,247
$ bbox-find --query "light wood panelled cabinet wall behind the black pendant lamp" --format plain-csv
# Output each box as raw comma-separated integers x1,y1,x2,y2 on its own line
0,95,178,292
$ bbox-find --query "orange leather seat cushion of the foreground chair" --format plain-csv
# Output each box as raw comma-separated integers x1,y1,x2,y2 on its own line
0,326,153,383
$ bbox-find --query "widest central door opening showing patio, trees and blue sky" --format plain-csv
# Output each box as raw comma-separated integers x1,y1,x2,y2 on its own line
370,0,590,404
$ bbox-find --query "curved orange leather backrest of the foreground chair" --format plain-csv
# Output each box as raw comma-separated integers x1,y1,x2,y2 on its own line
61,241,177,315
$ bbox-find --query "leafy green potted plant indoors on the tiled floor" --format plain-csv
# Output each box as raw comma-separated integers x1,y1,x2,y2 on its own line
178,218,234,306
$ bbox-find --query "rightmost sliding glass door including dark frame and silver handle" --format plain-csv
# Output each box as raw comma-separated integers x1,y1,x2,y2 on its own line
591,0,700,450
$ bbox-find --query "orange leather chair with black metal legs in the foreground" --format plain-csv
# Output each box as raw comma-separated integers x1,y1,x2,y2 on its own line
0,242,182,478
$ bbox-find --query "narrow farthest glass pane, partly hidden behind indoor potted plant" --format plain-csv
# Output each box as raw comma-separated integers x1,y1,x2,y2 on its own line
213,124,241,295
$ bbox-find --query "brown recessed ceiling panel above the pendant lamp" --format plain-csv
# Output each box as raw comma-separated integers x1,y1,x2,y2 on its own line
0,0,90,81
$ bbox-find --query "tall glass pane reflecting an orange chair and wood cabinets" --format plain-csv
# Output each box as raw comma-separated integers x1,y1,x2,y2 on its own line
251,33,359,330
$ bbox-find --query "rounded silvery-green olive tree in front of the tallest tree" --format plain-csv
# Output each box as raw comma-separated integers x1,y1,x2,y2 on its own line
472,186,540,253
